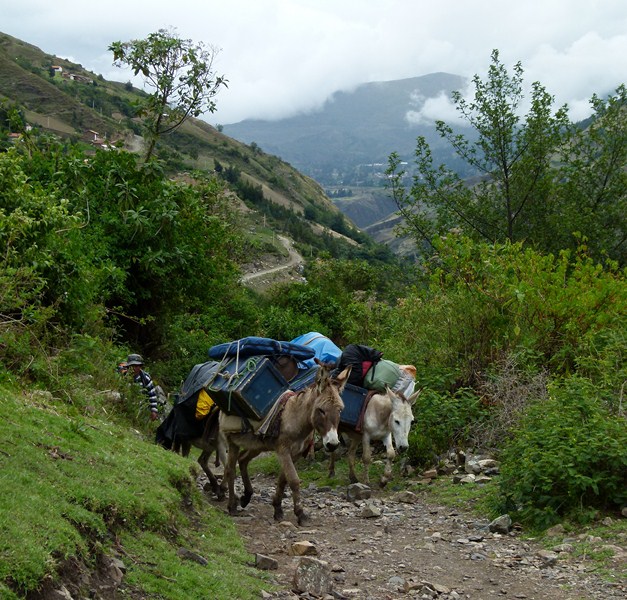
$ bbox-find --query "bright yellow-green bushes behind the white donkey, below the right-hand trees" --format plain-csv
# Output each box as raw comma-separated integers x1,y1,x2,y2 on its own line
387,236,627,385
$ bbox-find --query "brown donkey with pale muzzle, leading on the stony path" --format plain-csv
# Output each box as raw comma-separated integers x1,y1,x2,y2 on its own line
220,364,350,525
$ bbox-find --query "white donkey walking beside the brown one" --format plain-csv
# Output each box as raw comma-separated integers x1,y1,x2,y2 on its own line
329,388,420,487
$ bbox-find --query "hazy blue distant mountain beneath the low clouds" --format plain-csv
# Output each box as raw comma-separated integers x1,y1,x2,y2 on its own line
223,73,466,186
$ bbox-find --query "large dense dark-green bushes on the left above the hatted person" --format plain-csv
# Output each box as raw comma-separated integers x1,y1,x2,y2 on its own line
0,135,258,382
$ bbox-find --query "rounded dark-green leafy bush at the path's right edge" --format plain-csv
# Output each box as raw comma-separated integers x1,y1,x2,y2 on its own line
501,377,627,527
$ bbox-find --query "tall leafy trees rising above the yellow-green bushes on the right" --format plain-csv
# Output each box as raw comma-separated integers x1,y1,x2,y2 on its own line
388,50,627,254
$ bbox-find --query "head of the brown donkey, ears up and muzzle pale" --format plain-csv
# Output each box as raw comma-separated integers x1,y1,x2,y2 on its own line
312,364,351,452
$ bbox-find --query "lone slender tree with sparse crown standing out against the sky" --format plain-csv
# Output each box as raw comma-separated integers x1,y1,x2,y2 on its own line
109,29,227,160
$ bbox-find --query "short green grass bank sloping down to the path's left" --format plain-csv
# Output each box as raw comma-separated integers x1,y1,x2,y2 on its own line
0,387,271,600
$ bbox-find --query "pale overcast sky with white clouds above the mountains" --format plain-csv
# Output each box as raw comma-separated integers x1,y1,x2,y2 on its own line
0,0,627,124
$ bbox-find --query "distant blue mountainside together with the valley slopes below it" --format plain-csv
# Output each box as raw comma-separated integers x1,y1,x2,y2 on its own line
224,73,472,246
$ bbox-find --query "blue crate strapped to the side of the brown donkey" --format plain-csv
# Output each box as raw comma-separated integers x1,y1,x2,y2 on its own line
206,356,288,420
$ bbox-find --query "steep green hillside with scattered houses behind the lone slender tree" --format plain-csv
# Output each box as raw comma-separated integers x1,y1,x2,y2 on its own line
0,28,386,262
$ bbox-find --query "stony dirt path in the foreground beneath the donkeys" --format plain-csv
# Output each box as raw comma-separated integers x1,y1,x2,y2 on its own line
204,475,627,600
